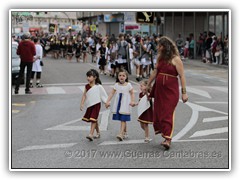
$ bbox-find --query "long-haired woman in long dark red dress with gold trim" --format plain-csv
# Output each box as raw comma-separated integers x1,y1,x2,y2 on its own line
148,37,188,149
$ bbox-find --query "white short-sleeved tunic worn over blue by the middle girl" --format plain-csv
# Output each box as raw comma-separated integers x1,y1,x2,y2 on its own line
112,82,133,115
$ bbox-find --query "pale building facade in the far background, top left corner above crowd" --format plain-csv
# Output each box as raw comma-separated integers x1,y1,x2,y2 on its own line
12,11,81,34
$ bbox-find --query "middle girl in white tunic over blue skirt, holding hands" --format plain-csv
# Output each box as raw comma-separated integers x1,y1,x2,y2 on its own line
106,69,135,141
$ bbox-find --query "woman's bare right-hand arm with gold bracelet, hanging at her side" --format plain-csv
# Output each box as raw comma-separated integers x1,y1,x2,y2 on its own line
173,57,188,103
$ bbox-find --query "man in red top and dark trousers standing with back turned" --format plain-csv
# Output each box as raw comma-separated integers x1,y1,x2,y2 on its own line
15,32,36,94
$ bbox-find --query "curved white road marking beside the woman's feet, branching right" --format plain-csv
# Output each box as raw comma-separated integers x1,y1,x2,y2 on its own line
172,102,228,140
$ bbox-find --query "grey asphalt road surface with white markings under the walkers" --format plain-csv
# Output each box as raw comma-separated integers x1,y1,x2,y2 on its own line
11,57,229,169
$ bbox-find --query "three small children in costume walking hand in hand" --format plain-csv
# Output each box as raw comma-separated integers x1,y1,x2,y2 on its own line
80,69,153,142
